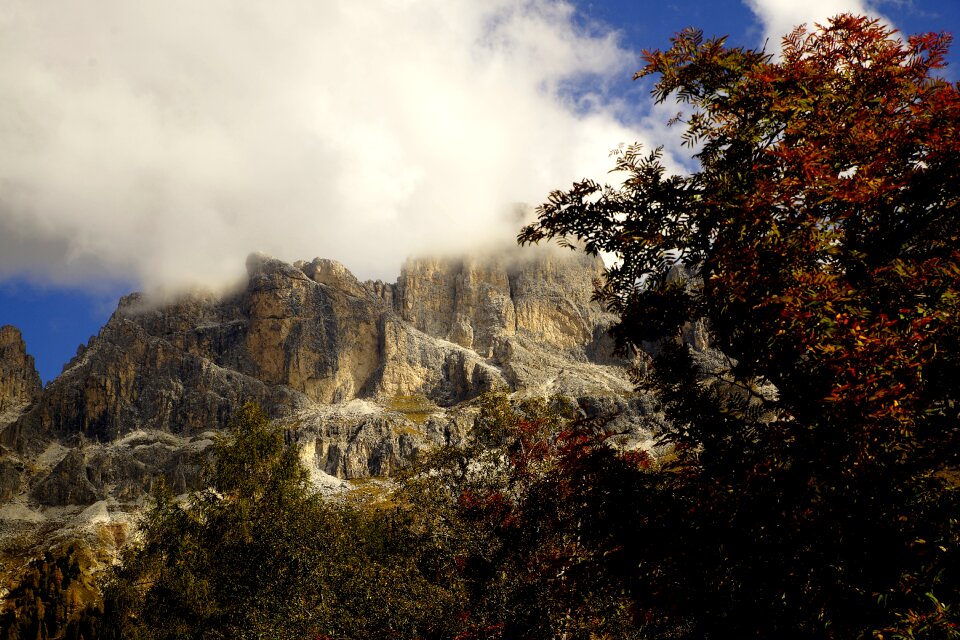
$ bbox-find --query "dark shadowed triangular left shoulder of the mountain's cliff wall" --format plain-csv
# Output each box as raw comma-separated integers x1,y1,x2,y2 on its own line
6,316,307,451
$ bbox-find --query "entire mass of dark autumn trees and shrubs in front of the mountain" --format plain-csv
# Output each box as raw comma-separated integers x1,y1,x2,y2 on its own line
7,16,960,640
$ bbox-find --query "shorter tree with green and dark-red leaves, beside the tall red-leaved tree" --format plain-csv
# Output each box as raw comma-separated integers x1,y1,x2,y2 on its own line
398,393,649,639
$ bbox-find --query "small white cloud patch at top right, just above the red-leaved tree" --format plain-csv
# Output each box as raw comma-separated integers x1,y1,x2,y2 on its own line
743,0,892,51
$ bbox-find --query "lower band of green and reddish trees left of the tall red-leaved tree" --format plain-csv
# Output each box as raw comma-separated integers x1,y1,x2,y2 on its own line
73,394,648,640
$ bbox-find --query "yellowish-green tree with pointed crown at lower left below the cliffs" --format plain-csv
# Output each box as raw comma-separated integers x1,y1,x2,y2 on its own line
99,405,325,638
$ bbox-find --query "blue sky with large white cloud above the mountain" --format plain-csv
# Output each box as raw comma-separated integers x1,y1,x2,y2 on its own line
0,0,960,381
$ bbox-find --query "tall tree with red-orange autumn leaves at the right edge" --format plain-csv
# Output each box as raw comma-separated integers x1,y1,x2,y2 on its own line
520,15,960,638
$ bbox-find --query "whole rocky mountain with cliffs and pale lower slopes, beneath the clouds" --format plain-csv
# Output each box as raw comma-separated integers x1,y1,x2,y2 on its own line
0,248,659,592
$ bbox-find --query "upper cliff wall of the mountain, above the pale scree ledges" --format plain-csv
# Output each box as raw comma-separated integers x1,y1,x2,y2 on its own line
0,244,629,444
